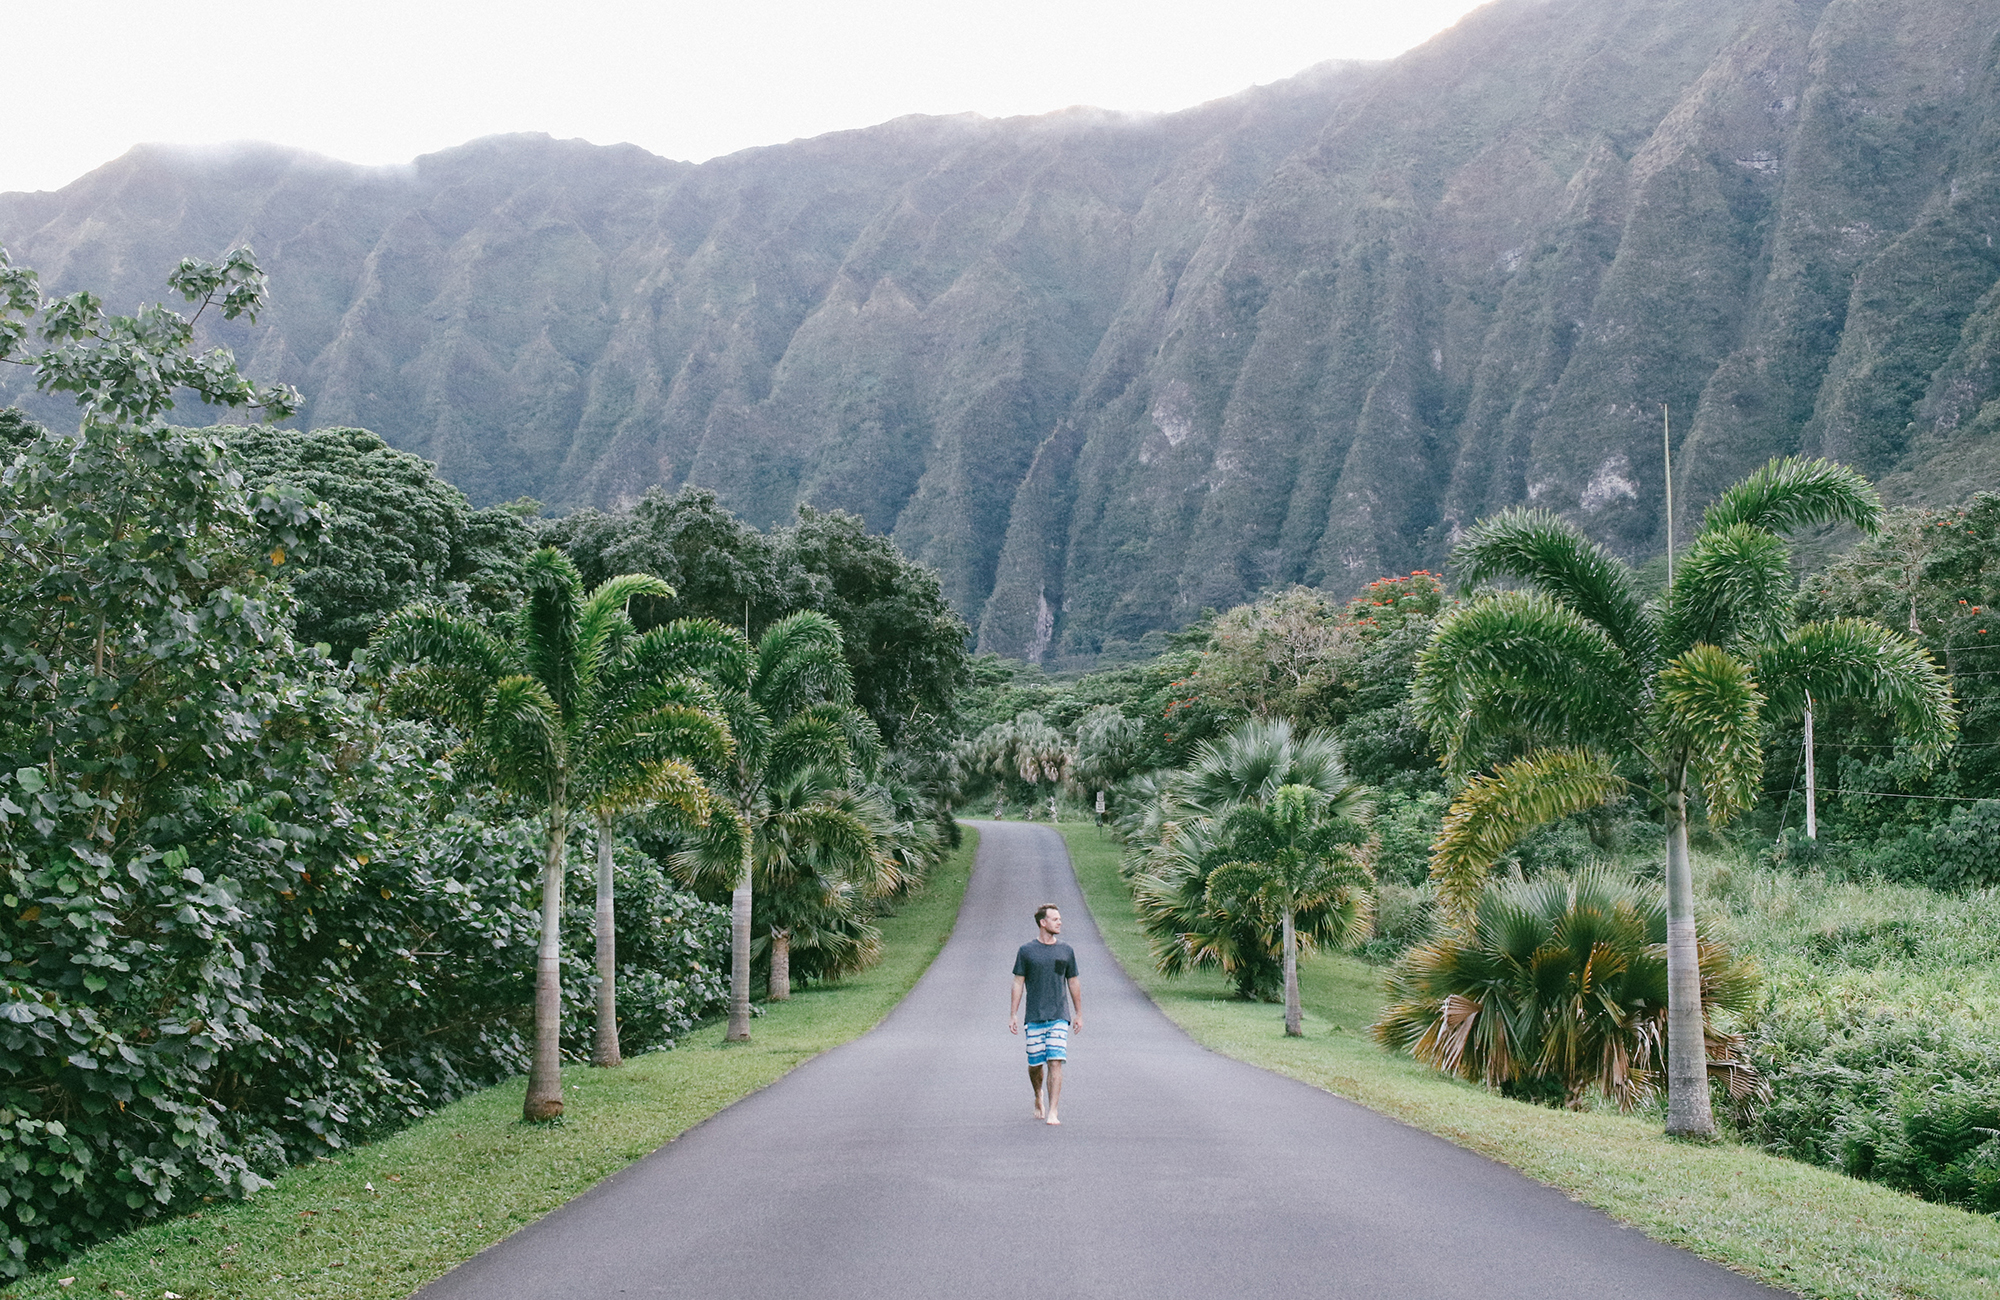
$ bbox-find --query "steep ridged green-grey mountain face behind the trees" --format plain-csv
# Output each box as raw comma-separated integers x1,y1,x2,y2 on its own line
11,0,2000,662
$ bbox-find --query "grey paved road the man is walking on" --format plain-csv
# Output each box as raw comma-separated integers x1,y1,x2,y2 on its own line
420,822,1784,1300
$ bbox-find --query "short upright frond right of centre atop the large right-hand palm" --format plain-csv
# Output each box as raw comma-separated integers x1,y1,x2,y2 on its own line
1664,524,1792,654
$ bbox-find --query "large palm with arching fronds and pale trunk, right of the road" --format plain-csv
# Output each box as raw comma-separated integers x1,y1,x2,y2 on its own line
1412,460,1956,1136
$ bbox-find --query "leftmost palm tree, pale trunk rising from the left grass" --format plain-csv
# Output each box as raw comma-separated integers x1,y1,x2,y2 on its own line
370,550,730,1120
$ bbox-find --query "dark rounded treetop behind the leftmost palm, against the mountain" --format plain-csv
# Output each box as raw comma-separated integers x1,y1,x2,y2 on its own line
227,424,536,660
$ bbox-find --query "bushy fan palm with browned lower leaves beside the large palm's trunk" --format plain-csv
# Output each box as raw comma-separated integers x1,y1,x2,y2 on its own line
1374,868,1756,1110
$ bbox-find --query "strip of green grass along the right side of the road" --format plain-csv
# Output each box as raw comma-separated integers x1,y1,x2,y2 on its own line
1062,824,2000,1300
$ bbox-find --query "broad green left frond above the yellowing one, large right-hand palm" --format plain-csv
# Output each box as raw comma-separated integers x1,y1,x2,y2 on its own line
1410,592,1644,772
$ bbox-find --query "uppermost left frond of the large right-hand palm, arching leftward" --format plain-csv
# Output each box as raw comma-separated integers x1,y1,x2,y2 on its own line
1452,510,1658,668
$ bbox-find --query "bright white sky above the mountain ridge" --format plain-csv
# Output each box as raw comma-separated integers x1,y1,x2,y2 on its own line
11,0,1474,190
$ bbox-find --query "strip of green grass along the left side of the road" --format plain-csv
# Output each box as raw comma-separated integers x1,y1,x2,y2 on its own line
4,830,978,1300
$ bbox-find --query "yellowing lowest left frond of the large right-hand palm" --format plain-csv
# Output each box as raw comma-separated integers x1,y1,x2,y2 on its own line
1430,748,1626,920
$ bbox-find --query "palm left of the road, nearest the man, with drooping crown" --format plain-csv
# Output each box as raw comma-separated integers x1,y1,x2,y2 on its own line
670,610,876,1042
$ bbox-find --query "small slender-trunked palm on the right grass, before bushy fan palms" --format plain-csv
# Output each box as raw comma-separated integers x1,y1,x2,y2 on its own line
1208,786,1374,1038
